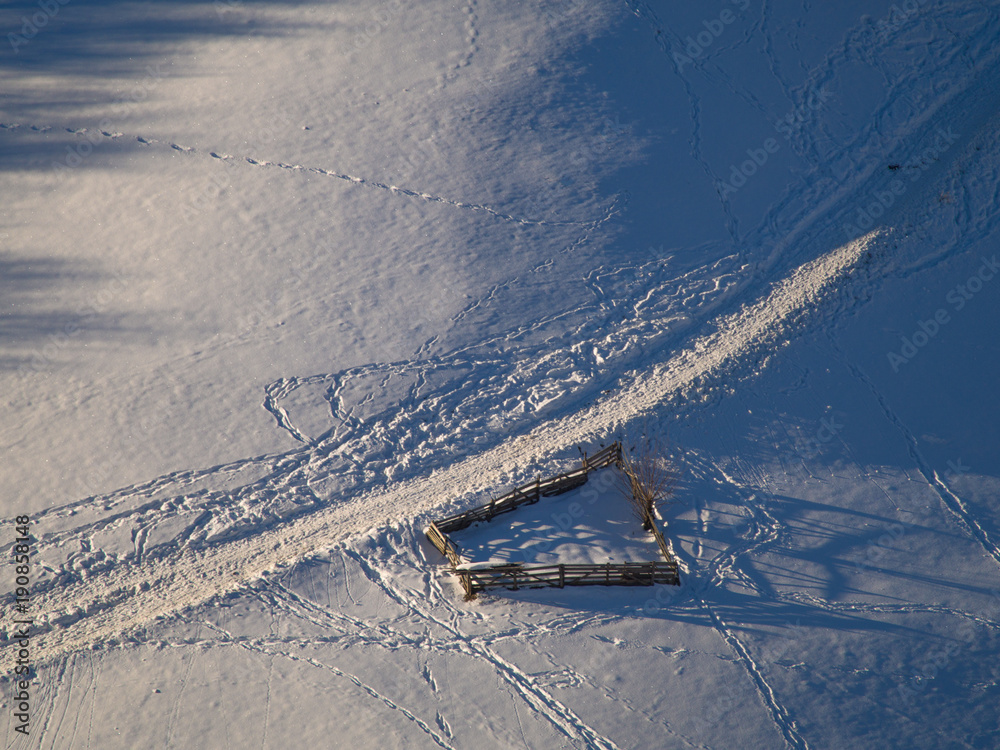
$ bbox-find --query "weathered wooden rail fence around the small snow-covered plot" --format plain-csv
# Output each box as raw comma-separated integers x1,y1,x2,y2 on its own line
426,442,680,599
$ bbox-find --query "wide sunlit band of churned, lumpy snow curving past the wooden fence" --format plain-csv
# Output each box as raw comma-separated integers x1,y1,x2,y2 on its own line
13,231,873,662
